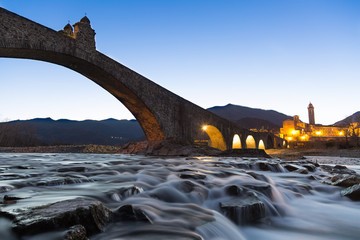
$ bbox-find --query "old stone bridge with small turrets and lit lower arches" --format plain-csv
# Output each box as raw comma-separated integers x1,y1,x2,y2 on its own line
0,8,283,150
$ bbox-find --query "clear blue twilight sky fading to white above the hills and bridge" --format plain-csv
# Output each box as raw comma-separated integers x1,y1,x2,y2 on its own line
0,0,360,124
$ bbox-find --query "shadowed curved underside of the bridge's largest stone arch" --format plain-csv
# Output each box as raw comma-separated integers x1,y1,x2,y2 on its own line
0,48,165,141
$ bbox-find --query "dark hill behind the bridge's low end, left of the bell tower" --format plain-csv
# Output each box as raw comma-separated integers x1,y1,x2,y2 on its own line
208,104,293,129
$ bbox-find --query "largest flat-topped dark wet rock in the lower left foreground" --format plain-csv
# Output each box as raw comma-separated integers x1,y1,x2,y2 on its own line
13,198,111,235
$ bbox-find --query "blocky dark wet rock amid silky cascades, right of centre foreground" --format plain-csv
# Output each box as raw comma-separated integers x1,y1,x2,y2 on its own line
219,194,265,224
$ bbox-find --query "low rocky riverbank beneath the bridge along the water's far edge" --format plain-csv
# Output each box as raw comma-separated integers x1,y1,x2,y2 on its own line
0,141,360,160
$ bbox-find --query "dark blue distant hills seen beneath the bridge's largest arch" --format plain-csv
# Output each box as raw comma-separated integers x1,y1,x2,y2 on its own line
0,118,145,145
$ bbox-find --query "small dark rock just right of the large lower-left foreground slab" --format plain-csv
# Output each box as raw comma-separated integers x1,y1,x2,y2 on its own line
112,205,151,223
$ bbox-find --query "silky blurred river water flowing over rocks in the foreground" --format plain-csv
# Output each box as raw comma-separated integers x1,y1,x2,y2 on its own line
0,154,360,240
